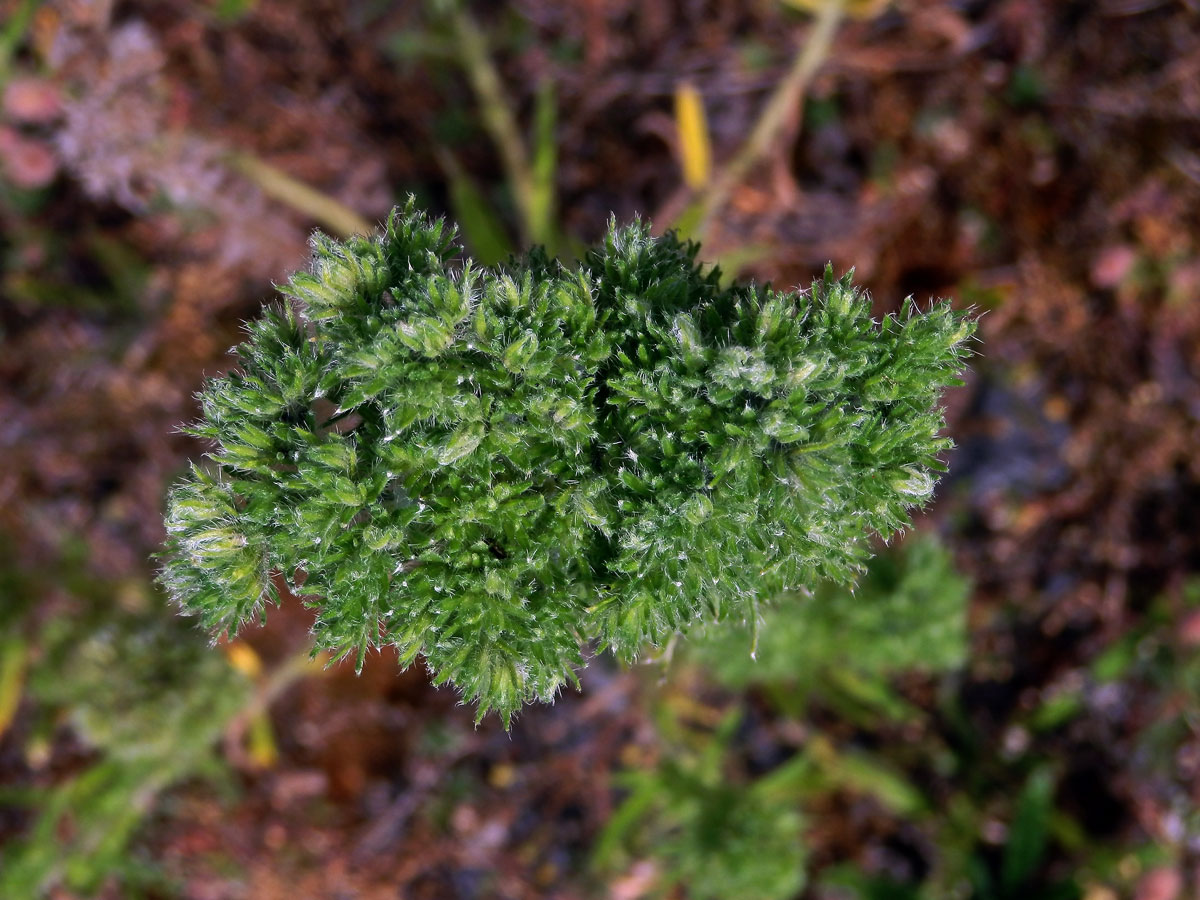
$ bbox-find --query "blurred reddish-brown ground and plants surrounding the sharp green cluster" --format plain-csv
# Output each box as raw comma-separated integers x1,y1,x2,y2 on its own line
0,0,1200,900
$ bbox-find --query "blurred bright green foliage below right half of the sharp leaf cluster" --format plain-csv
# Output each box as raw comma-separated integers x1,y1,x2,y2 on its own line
595,536,970,900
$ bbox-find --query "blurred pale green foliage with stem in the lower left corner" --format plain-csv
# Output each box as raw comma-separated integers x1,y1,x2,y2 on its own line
0,560,252,898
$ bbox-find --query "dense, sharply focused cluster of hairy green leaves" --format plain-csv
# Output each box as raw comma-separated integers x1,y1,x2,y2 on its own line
163,202,973,719
